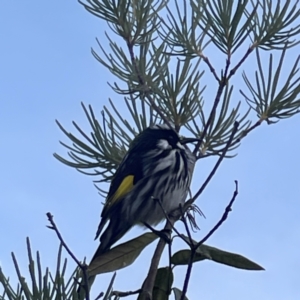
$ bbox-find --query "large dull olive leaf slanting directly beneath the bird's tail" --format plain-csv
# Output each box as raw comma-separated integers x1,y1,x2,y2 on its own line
87,232,158,276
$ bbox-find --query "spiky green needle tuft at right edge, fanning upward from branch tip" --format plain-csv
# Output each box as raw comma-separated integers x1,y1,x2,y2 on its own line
240,47,300,124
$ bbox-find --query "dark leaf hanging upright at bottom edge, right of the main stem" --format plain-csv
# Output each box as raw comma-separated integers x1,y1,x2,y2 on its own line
152,267,174,300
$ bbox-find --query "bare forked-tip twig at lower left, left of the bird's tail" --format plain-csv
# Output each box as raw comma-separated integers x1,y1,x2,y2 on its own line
46,212,90,300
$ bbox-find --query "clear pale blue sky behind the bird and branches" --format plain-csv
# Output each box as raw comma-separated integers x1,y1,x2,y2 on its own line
0,0,300,300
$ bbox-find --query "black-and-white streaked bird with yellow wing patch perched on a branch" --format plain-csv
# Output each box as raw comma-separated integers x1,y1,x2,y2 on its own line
78,123,199,296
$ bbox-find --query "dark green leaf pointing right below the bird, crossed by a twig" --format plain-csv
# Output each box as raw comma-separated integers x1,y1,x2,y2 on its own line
171,244,264,271
